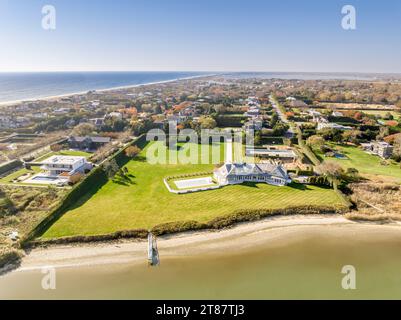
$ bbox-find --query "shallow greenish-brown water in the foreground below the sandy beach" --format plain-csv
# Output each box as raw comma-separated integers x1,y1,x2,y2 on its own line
0,226,401,299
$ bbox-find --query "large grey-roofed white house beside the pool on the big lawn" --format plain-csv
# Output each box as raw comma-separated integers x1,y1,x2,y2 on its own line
214,163,291,186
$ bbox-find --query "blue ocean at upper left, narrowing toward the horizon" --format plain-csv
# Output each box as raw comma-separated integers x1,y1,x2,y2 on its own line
0,72,203,102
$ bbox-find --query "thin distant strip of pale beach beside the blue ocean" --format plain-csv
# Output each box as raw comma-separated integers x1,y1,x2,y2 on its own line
0,73,217,107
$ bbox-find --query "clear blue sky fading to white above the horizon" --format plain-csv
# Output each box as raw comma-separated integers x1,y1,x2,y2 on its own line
0,0,401,73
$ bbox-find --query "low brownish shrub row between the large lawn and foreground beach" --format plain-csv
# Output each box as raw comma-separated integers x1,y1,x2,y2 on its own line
29,206,348,246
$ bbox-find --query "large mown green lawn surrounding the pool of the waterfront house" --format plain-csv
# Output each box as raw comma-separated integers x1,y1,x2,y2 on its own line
43,144,344,238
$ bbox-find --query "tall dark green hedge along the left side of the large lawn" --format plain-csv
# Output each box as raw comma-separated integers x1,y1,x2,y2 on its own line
21,135,146,246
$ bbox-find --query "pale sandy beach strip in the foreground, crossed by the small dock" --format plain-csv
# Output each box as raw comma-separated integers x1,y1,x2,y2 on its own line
14,215,401,271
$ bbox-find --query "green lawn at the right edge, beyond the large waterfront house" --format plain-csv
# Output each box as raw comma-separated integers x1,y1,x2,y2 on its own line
315,145,401,182
